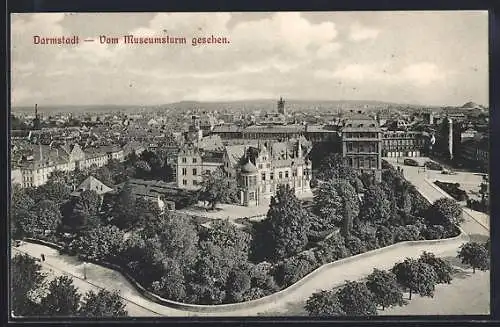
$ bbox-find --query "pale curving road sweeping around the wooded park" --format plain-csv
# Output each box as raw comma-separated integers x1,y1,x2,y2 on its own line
12,159,489,316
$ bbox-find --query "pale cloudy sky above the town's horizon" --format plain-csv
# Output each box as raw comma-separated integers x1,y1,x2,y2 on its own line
11,11,488,106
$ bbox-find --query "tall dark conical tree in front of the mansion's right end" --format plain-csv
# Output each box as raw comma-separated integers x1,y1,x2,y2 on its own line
264,185,310,260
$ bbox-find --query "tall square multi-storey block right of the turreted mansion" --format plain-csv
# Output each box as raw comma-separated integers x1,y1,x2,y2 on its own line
342,112,382,181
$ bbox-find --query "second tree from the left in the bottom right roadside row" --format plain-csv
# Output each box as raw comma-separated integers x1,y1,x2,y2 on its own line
337,281,377,316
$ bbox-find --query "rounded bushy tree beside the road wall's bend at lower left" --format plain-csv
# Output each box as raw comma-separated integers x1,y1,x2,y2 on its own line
70,226,124,260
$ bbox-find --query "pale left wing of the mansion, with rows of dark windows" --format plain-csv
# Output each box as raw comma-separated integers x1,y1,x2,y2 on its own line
176,147,223,190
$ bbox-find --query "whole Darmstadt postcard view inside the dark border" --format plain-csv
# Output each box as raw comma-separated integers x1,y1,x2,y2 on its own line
8,10,491,321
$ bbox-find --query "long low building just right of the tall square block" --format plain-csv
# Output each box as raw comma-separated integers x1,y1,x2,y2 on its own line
382,131,430,157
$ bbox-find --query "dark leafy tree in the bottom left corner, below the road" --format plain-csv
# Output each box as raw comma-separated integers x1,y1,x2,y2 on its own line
10,254,45,316
